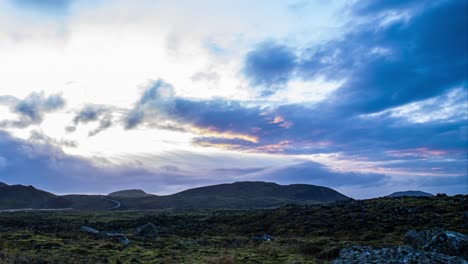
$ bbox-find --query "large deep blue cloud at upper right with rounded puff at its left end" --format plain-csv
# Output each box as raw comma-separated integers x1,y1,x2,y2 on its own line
244,1,468,115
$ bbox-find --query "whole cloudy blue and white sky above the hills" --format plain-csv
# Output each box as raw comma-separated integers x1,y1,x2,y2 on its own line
0,0,468,199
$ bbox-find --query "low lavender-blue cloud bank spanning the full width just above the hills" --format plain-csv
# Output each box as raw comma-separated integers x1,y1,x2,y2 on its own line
0,131,466,197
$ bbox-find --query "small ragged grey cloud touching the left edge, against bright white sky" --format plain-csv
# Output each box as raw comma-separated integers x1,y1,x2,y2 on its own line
0,92,65,127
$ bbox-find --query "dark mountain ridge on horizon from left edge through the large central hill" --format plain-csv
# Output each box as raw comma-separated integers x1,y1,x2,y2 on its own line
0,182,350,210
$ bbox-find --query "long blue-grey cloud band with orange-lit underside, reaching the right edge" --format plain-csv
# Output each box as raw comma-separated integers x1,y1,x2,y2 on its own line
122,82,468,177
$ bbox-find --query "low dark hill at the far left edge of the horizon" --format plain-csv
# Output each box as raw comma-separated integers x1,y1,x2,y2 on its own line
0,185,70,209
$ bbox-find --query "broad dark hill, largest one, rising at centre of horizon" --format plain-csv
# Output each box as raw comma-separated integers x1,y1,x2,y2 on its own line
111,182,349,210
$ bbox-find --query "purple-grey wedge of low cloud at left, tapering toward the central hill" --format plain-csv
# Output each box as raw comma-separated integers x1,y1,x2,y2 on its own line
0,131,224,193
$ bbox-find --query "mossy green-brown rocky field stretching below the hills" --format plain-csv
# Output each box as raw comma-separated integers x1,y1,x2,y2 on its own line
0,195,468,263
